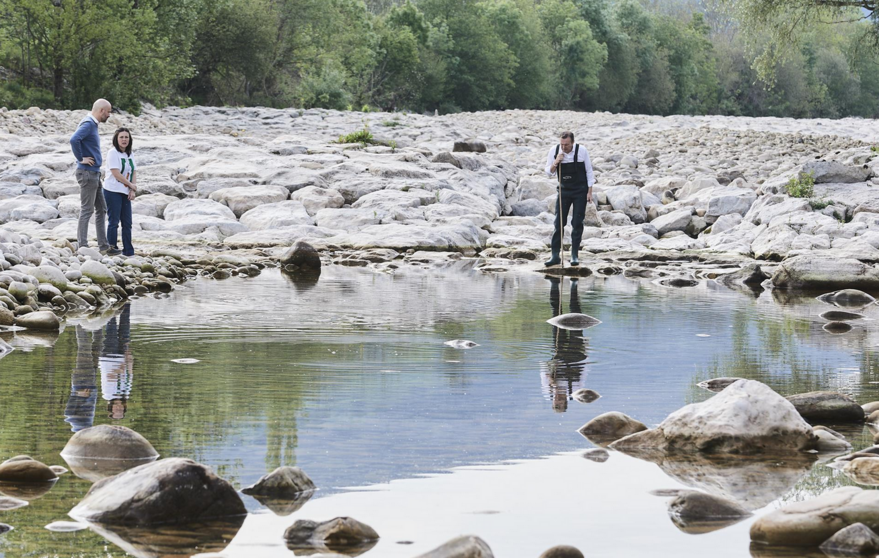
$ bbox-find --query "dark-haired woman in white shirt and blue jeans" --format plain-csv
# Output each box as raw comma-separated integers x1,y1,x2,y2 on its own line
104,128,137,256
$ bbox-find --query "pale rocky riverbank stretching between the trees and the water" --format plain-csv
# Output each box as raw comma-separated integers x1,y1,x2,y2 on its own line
0,107,879,319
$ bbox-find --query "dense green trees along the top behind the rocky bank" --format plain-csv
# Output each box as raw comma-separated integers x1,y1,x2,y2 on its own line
0,0,879,117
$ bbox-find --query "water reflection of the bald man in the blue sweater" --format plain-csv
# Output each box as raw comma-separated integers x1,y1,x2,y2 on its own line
64,325,103,432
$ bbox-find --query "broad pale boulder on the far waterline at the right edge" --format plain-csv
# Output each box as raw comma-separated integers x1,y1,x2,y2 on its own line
772,254,879,291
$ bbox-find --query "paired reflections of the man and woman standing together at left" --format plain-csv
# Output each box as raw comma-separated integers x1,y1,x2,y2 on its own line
64,304,134,432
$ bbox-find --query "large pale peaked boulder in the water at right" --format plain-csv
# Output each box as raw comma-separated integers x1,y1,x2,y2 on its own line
611,380,817,454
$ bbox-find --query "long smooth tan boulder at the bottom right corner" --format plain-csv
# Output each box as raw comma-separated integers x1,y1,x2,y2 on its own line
751,486,879,547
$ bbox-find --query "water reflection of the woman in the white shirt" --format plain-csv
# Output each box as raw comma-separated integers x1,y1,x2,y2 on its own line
98,304,134,419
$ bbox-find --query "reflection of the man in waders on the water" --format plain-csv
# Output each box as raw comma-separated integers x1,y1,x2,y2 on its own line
540,277,586,413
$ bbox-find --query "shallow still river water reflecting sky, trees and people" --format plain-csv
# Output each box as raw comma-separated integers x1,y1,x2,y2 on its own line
0,262,879,558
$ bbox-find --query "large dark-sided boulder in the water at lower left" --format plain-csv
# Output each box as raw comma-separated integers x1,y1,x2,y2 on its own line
70,457,247,526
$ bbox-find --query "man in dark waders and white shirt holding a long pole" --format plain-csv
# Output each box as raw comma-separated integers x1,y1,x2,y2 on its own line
544,132,595,267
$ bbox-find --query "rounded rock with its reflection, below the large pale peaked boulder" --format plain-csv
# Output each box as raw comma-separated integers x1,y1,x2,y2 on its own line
668,490,751,535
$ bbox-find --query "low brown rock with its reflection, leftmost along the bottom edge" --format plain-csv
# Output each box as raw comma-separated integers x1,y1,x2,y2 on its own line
284,517,379,556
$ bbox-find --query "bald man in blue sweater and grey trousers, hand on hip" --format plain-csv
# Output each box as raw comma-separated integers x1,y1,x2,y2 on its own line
70,99,113,253
